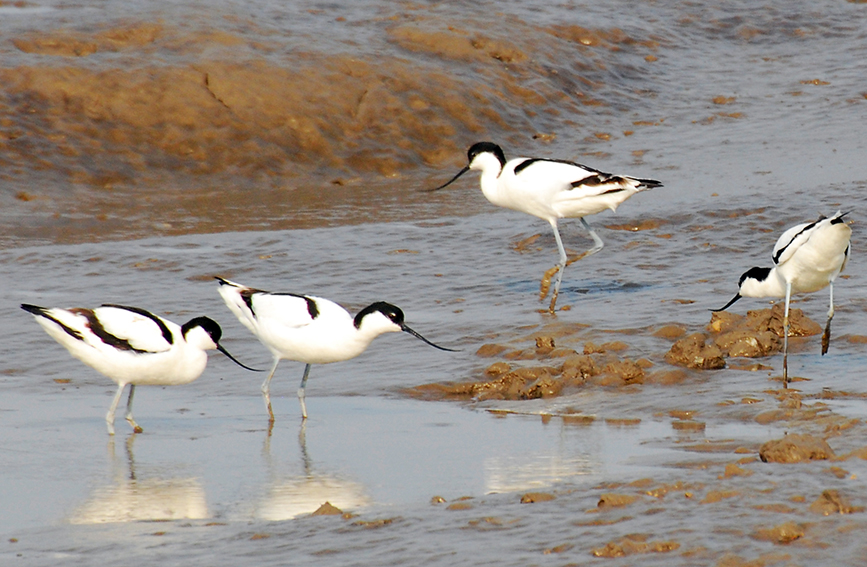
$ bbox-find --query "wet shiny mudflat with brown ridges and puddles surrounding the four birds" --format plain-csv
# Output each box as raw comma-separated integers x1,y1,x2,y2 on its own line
0,3,867,566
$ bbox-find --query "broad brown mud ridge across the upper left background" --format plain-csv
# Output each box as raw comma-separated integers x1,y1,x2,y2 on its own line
0,40,488,184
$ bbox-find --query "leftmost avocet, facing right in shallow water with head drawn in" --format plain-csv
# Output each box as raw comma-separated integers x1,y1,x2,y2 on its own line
21,304,254,435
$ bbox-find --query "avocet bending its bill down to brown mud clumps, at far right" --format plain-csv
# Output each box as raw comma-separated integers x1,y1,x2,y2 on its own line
714,211,852,387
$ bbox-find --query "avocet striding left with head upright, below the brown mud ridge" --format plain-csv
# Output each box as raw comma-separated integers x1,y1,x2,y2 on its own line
431,142,662,313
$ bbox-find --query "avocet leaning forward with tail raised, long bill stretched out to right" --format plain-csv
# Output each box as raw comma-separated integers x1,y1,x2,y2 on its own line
216,277,452,423
